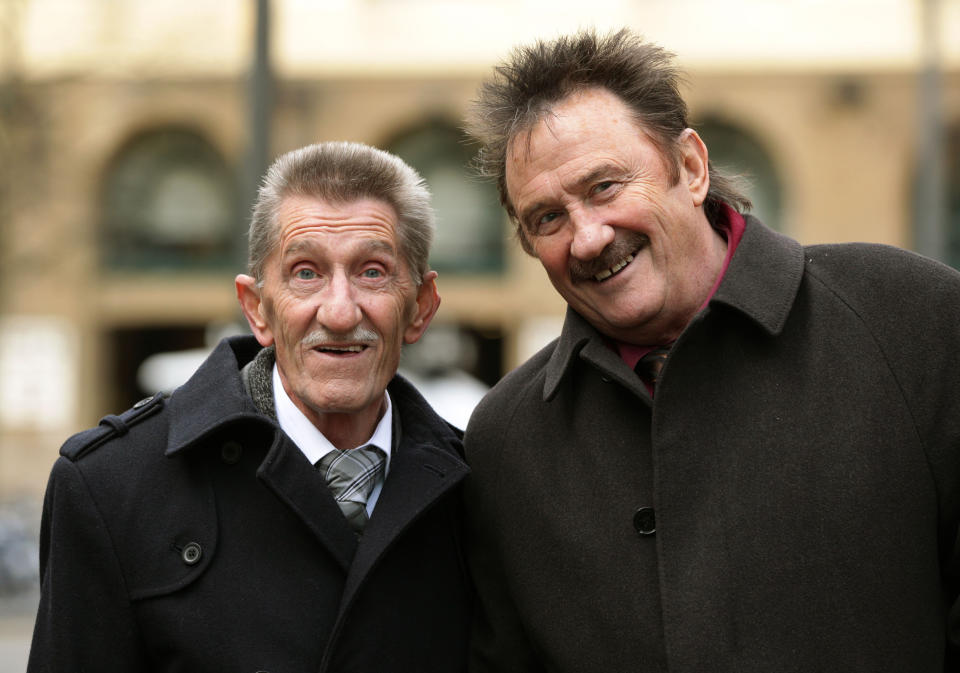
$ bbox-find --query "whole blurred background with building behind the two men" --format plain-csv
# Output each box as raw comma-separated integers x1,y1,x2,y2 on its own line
0,0,960,671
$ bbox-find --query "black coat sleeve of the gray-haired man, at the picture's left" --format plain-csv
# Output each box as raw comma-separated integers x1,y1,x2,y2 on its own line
27,458,149,673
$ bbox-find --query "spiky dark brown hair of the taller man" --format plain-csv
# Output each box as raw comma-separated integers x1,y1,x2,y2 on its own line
467,28,751,252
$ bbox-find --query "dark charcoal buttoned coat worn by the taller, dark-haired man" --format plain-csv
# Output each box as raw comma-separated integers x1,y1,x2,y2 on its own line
465,218,960,673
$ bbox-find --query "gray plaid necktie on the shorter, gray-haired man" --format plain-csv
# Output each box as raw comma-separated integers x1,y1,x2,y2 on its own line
317,445,386,533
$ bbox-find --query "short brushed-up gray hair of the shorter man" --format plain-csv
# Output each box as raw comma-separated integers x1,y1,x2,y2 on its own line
248,142,435,285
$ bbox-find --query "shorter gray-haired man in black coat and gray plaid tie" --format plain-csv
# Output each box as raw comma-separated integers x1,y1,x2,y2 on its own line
28,143,472,673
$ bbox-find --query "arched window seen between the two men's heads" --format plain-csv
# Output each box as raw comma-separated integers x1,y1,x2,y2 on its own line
387,122,504,273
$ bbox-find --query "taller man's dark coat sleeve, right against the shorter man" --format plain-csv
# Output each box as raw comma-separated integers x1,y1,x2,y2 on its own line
464,402,545,673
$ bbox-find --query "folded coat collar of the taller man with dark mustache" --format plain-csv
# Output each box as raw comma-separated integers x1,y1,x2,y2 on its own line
543,215,804,400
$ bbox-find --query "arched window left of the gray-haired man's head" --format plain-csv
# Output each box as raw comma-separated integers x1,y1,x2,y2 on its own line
101,129,243,268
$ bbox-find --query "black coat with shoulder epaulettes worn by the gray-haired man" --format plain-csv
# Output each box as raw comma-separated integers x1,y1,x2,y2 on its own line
28,337,472,673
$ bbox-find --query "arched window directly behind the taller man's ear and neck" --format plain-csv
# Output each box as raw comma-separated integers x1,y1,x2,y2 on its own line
697,119,783,231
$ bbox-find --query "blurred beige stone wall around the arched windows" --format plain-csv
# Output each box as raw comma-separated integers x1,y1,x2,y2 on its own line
0,65,960,493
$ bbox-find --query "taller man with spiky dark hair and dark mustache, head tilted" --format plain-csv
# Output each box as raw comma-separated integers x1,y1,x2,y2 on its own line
465,31,960,673
